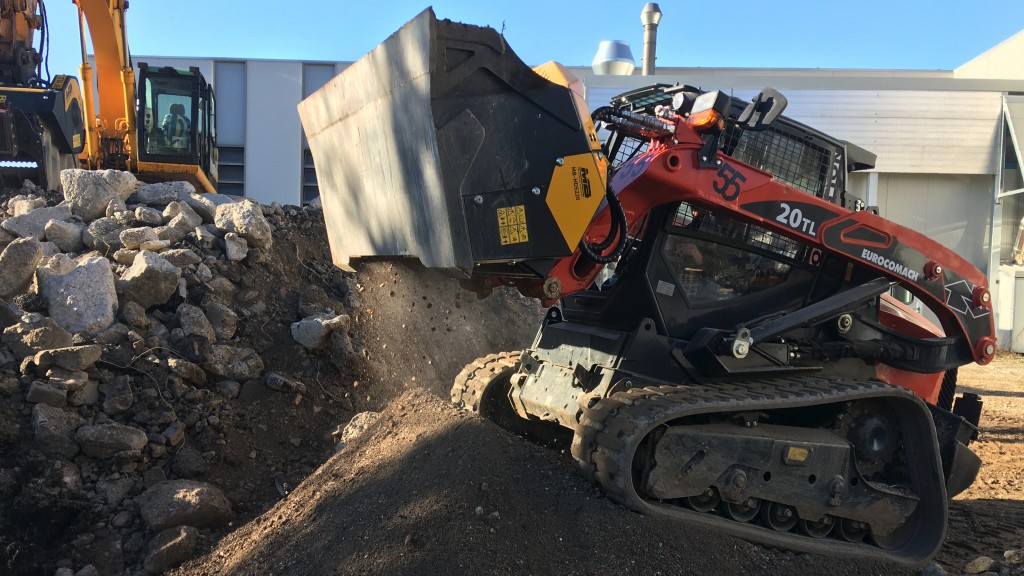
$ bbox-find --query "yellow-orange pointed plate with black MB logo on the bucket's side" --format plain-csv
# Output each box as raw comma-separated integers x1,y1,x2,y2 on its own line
545,153,606,251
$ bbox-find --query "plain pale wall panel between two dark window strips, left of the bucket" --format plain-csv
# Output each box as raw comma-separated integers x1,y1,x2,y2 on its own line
246,60,302,204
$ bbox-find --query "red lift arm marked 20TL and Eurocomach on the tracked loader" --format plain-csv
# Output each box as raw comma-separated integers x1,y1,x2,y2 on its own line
549,124,995,364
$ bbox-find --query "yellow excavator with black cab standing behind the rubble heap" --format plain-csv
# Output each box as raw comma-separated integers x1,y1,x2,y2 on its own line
0,0,217,193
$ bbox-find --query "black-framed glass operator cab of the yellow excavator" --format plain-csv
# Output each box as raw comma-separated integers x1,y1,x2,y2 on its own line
137,64,217,192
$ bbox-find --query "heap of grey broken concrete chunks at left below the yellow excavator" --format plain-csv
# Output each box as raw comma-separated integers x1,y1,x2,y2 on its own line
0,170,352,576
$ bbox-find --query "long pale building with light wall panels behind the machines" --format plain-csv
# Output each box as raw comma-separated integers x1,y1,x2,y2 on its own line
135,32,1024,352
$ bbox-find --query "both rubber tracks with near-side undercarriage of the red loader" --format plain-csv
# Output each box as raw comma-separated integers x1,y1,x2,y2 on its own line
452,353,946,566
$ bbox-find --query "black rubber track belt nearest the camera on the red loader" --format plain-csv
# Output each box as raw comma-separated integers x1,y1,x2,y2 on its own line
572,377,945,566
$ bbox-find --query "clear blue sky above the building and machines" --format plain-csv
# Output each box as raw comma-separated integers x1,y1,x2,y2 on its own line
39,0,1024,81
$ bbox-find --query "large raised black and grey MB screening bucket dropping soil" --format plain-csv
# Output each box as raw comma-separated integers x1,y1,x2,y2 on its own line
299,8,606,277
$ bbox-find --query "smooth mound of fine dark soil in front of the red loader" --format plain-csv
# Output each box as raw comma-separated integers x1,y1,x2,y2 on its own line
174,390,900,576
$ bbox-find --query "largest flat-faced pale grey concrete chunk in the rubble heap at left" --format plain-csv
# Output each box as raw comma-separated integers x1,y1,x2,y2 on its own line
37,256,118,334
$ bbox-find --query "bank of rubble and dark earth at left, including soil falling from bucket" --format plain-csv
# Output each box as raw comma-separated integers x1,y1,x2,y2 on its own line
0,176,536,576
